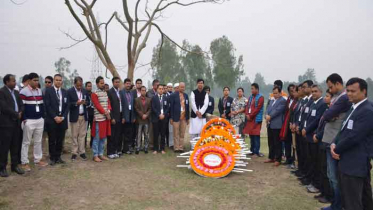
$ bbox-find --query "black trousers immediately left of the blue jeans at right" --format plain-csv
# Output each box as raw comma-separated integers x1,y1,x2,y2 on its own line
319,143,333,200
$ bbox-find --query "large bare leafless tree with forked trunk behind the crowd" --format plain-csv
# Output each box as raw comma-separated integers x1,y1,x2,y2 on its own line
65,0,225,79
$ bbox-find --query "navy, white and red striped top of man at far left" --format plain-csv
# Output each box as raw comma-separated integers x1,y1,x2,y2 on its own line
19,86,44,120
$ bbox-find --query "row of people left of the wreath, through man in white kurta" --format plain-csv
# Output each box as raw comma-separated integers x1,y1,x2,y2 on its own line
0,73,213,177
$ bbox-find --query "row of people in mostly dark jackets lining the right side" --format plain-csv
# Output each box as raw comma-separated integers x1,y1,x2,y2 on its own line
264,74,373,210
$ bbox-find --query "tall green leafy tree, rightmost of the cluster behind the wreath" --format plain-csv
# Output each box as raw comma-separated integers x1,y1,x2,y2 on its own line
210,36,244,87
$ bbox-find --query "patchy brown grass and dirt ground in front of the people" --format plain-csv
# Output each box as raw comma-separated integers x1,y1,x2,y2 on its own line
0,128,328,210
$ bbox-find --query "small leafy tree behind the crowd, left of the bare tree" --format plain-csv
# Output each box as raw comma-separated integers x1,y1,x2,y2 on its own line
54,57,79,89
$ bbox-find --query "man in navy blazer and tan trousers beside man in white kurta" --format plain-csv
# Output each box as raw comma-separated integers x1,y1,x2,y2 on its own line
169,82,189,153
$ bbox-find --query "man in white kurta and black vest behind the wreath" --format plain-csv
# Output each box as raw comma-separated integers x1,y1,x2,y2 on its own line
189,79,209,149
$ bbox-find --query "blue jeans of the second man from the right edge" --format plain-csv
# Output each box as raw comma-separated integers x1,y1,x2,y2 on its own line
326,145,342,210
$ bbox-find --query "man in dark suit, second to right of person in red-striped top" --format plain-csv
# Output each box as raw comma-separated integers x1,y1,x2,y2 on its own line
118,78,136,155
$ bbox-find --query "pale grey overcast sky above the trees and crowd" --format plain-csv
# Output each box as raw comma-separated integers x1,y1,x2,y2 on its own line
0,0,373,84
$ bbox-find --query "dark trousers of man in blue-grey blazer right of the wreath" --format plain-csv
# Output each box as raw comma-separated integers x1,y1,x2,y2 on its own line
268,128,282,162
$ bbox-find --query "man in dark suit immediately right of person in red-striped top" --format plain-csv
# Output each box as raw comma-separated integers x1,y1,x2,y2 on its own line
107,77,123,159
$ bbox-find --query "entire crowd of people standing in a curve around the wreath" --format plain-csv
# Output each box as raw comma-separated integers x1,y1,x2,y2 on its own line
0,73,373,210
